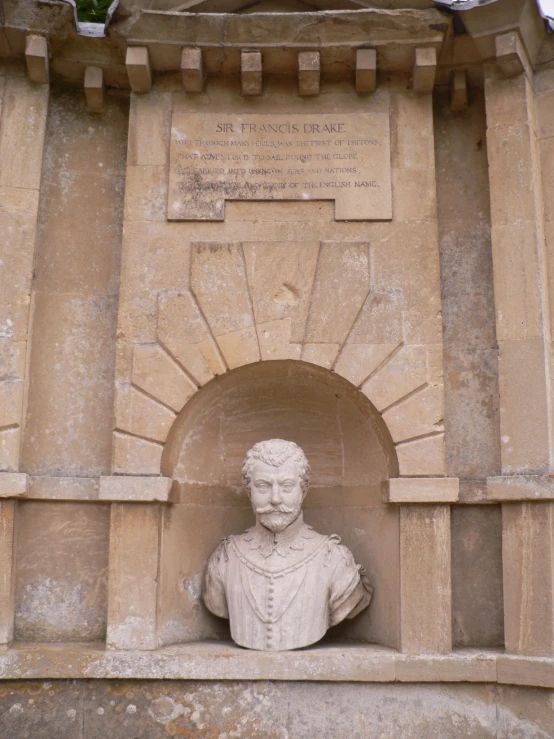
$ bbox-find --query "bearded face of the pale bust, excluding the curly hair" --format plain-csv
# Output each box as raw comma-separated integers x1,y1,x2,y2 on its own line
250,460,303,533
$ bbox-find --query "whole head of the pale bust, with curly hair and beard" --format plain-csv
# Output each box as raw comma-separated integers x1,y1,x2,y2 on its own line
242,439,310,533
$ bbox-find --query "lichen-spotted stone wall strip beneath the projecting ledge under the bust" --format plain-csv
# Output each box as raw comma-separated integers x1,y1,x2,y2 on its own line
0,680,554,739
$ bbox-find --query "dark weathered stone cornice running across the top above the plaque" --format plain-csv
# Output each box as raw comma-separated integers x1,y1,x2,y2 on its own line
0,0,551,89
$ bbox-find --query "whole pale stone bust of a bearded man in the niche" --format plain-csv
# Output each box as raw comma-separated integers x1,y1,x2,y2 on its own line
203,439,372,651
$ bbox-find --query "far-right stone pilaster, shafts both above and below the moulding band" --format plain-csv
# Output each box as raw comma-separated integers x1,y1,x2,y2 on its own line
485,50,554,655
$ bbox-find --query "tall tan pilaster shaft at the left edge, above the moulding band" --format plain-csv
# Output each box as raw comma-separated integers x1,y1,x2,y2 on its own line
0,66,49,471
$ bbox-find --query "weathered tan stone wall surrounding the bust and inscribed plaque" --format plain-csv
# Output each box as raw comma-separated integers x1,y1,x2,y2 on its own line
0,0,554,739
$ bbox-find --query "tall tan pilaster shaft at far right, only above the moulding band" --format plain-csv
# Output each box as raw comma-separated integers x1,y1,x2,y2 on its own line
485,65,552,474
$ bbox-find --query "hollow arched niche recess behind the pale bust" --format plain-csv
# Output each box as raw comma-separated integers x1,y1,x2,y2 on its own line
159,360,399,647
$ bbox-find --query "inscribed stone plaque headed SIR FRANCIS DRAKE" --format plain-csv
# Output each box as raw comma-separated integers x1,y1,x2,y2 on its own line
167,108,392,221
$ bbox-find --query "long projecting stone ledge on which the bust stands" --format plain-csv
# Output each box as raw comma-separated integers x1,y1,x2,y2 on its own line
0,642,544,688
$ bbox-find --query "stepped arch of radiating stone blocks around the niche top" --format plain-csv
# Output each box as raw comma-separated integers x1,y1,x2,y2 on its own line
113,241,445,476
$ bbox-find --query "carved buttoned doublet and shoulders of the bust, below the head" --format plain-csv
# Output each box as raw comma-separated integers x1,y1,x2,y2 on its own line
204,516,370,651
